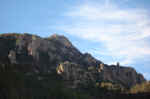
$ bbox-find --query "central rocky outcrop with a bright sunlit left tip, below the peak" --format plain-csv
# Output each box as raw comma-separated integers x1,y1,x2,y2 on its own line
56,61,98,88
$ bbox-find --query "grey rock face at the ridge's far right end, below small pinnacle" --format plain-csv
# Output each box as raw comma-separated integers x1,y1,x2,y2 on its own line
99,65,145,87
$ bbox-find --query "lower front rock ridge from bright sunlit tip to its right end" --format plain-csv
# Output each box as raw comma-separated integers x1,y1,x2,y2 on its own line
56,61,145,88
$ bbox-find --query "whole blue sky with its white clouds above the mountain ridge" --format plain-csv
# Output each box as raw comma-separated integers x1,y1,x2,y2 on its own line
0,0,150,80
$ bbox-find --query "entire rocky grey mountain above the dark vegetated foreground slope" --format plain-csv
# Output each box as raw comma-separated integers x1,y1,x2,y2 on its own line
0,34,145,88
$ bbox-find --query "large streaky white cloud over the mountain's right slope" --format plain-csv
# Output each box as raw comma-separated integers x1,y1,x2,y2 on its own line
59,2,150,64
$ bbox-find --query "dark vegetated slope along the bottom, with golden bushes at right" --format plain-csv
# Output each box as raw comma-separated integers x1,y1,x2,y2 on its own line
0,64,150,99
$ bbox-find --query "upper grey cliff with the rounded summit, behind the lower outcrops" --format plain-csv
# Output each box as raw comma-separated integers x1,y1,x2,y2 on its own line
0,34,101,67
